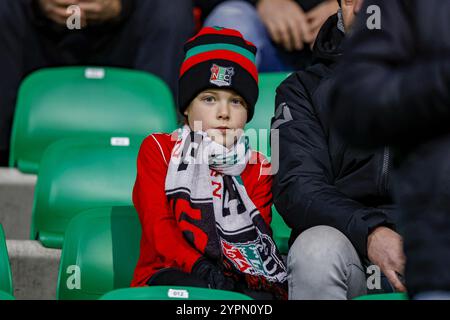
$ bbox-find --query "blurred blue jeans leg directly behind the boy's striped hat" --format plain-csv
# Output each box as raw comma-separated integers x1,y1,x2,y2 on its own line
204,0,311,72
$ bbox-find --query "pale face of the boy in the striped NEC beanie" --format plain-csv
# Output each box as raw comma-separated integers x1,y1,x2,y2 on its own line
184,89,247,148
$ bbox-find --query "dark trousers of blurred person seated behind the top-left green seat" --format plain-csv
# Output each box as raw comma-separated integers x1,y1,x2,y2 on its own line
0,0,194,166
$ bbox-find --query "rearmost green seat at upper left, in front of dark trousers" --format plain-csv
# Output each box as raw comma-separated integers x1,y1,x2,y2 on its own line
9,67,177,173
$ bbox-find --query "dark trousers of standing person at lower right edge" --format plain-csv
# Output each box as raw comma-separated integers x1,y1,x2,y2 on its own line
394,134,450,298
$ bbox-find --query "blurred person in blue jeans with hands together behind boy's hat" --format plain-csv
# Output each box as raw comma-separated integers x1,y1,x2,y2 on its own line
196,0,338,72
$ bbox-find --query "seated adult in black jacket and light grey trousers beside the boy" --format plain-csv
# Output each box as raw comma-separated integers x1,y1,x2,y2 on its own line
272,1,404,299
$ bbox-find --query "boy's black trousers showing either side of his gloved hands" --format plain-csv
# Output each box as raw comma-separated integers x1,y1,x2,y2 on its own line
147,268,274,300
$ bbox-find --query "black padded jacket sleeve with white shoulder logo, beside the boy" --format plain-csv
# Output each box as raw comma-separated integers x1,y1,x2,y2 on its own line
272,75,391,257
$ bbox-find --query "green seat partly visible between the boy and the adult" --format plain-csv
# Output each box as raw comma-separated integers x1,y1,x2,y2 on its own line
245,72,291,254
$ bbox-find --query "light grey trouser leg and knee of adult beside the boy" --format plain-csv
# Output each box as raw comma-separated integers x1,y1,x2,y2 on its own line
288,226,365,299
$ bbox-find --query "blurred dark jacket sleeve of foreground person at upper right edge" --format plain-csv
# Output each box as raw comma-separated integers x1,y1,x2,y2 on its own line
330,0,450,147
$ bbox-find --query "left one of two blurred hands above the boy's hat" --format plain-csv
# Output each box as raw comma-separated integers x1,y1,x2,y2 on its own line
257,0,314,51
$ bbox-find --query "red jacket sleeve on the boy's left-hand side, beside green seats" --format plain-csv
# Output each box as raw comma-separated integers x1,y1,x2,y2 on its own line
133,136,201,272
